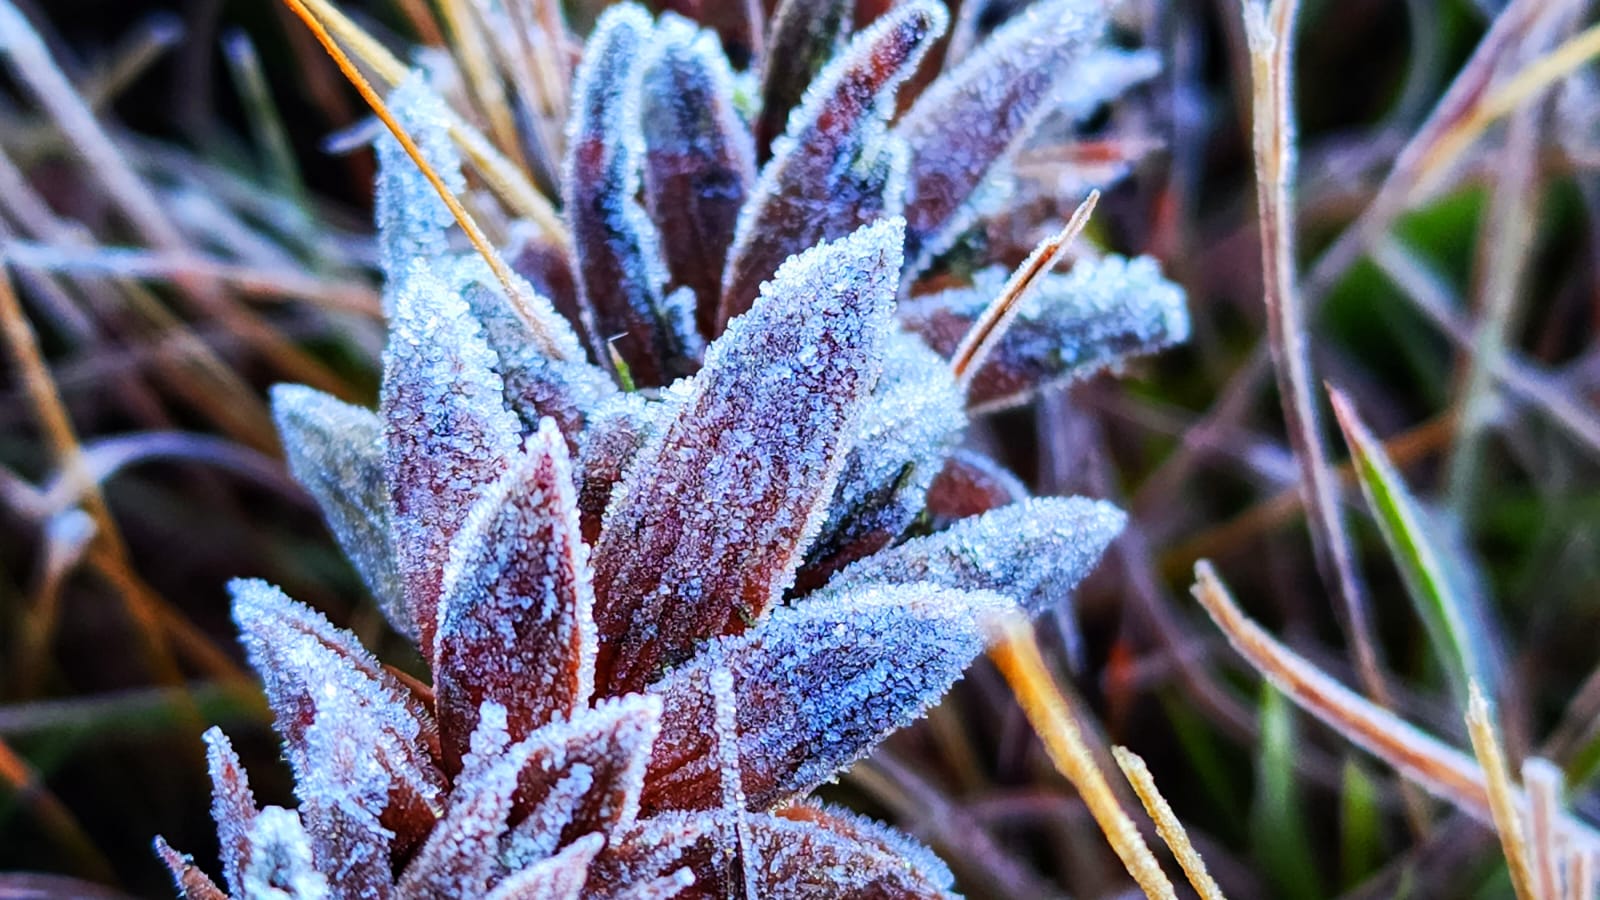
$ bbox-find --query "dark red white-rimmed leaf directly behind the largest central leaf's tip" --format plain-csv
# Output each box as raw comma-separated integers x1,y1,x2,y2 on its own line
718,0,947,323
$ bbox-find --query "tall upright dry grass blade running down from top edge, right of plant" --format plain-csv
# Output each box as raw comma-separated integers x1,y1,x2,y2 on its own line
1245,0,1392,706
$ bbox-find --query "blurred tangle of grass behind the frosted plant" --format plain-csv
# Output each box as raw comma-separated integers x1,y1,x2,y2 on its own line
0,0,1600,897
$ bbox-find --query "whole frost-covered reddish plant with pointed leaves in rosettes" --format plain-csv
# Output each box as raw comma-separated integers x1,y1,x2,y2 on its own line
158,0,1187,900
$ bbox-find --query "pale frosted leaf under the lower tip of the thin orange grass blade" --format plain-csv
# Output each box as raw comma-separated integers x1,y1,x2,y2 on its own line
451,256,616,447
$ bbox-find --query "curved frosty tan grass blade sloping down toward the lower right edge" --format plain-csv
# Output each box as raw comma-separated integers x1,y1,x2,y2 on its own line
1194,562,1600,849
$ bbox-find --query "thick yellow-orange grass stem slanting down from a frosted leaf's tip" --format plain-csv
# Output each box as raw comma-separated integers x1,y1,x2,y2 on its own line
989,615,1178,900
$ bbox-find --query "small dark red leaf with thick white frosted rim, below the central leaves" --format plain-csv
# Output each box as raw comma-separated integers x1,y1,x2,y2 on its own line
517,693,661,842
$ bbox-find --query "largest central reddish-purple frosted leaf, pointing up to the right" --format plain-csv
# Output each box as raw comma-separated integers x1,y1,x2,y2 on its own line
594,219,901,693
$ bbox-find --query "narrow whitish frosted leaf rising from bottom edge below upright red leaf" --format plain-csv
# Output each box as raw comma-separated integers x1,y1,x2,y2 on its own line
395,703,526,900
